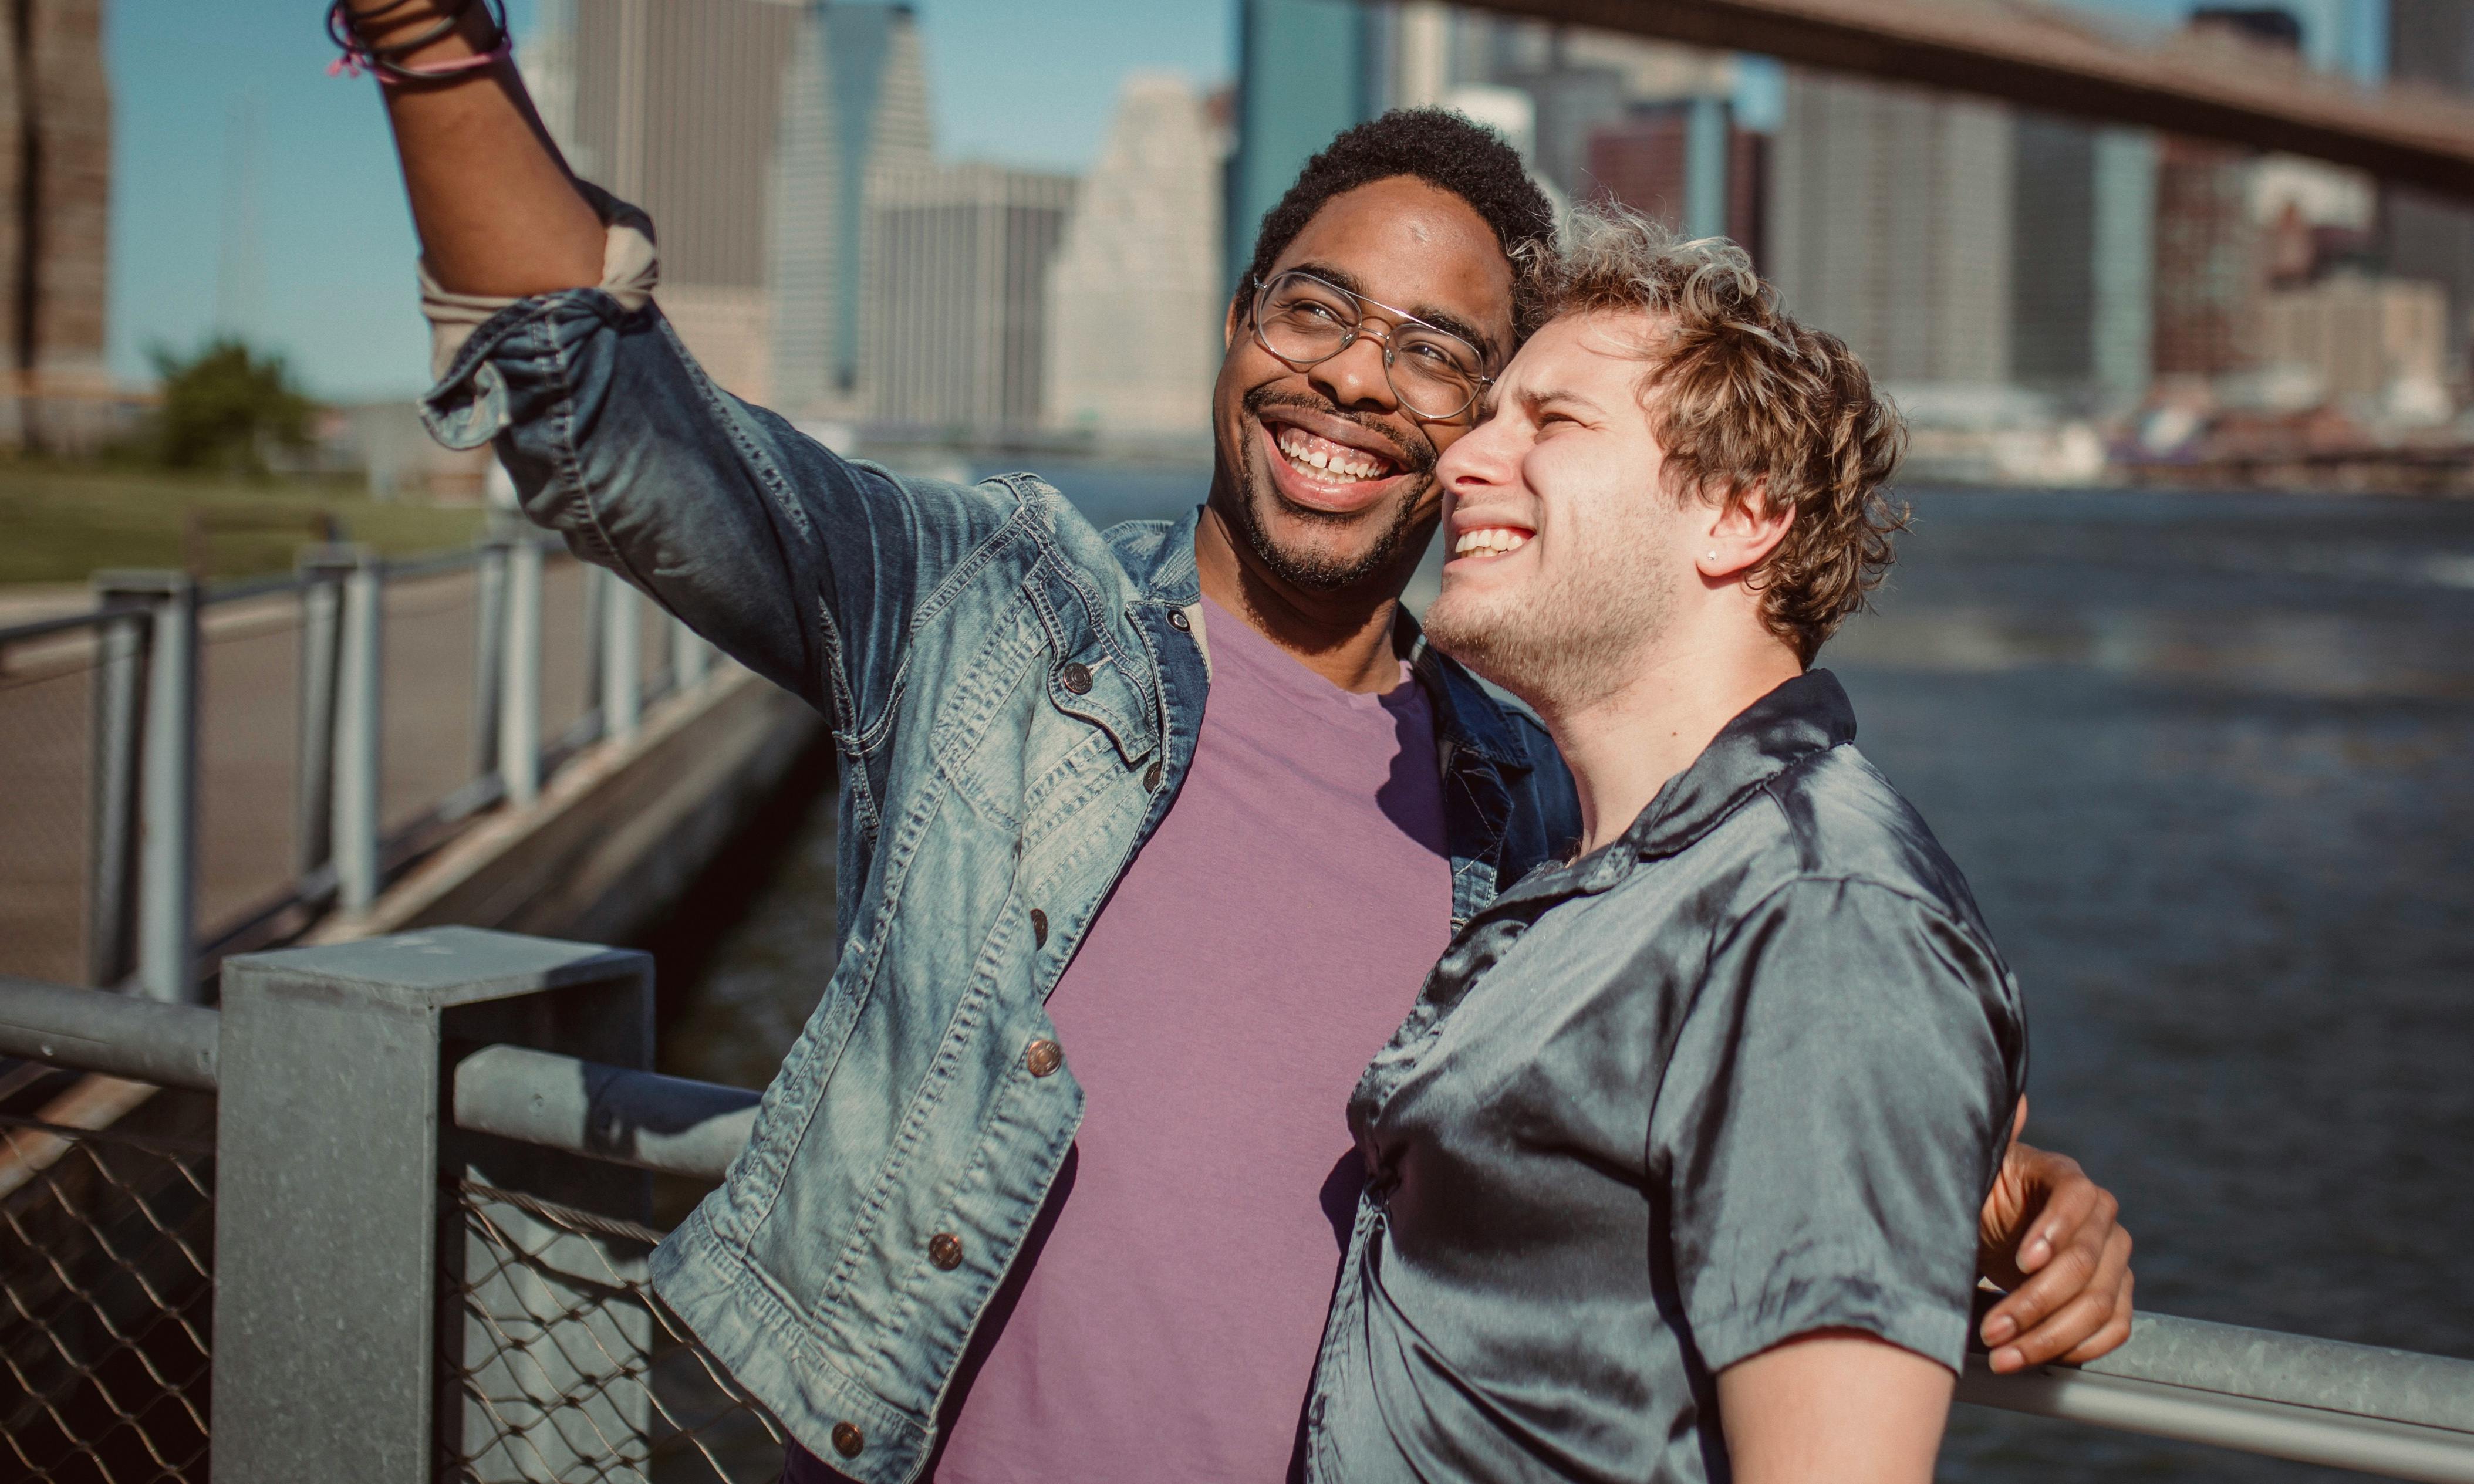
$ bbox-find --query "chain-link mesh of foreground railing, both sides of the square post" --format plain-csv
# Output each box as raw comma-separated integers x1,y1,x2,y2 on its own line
0,1079,787,1484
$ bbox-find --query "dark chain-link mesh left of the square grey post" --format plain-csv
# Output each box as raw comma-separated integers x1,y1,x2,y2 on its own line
0,1079,215,1484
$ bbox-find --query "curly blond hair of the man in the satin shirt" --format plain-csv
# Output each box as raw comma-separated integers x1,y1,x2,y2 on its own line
1546,203,1908,665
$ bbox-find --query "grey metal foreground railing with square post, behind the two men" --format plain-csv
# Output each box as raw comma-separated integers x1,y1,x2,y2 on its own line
0,928,2474,1484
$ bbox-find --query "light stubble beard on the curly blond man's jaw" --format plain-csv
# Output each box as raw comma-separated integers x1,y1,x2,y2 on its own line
1423,532,1682,717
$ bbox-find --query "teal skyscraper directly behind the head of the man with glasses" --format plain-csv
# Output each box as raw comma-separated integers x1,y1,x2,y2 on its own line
1227,0,1388,293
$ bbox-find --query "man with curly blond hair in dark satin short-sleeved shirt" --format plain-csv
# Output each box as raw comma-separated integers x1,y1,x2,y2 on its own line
1309,210,2026,1484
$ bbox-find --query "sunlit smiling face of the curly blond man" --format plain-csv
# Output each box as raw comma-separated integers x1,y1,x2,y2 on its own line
1425,314,1702,712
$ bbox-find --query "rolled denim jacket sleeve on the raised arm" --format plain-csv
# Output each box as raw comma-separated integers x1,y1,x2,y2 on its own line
423,289,1017,737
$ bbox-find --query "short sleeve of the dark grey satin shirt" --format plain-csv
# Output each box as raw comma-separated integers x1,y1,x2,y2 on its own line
1650,878,2024,1370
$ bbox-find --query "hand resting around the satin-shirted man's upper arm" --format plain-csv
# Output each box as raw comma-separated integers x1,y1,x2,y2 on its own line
1977,1098,2130,1375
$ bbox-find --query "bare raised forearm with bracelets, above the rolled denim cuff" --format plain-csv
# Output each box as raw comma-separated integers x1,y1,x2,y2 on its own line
346,0,601,297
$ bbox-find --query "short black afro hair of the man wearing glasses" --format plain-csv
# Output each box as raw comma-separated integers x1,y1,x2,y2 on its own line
1234,109,1554,344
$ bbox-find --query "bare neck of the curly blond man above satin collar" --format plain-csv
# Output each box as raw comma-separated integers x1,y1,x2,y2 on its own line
1539,621,1804,853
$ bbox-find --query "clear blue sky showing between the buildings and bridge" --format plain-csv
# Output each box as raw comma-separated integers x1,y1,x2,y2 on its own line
104,0,2382,401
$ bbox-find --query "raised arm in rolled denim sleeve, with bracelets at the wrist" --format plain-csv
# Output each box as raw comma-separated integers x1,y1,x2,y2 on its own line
346,0,1017,737
